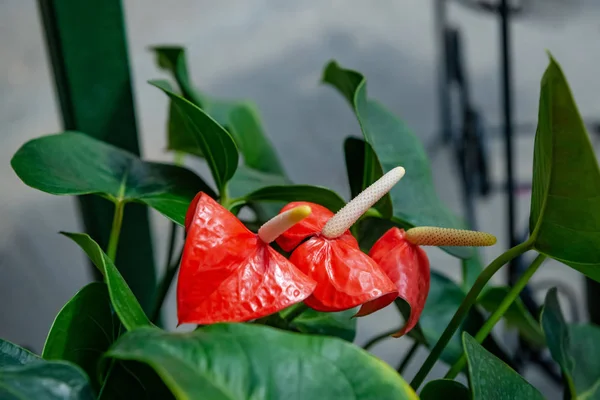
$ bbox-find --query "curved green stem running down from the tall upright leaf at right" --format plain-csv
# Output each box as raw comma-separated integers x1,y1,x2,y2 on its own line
410,239,532,390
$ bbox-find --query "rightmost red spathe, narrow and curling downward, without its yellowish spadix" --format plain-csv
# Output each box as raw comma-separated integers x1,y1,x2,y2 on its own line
357,228,430,337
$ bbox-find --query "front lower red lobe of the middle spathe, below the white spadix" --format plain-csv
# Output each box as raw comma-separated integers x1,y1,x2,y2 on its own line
290,237,397,311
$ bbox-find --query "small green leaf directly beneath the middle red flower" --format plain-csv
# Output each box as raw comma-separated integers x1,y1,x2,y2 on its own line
291,308,358,342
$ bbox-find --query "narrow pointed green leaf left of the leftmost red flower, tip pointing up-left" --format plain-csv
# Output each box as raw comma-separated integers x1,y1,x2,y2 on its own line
61,232,151,330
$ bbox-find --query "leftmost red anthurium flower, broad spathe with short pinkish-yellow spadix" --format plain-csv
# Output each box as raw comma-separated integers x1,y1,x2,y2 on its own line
177,193,316,324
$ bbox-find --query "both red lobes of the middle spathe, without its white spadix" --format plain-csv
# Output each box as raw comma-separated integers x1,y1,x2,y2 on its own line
277,202,397,312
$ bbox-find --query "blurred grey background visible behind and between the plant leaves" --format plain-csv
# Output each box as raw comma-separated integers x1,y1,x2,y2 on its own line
0,0,600,399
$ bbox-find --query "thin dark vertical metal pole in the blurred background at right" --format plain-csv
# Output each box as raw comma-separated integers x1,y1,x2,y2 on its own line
500,0,518,284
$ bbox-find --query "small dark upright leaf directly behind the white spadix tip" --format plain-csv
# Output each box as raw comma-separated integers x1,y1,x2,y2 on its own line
344,137,394,219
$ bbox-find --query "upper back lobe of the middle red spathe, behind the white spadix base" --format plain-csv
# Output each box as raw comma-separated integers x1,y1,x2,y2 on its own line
276,201,356,251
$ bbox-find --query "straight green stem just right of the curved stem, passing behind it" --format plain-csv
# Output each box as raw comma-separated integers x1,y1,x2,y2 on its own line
444,254,546,379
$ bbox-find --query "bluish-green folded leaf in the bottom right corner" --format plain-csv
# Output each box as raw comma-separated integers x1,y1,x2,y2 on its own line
541,288,600,400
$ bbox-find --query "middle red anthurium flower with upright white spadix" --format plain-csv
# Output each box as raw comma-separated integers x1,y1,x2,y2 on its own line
277,167,404,311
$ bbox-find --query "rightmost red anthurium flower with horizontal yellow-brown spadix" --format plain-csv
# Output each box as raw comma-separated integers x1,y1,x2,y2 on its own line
357,227,496,337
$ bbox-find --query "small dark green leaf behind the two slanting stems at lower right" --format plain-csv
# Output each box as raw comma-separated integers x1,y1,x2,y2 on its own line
477,286,546,348
